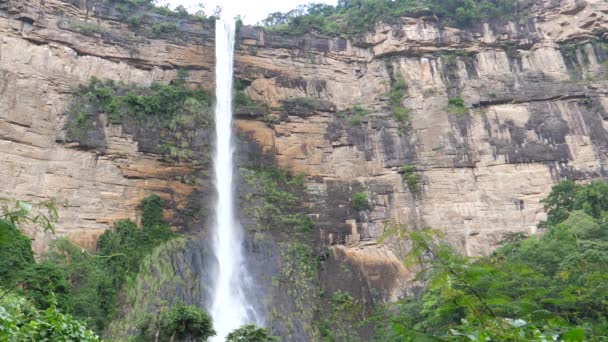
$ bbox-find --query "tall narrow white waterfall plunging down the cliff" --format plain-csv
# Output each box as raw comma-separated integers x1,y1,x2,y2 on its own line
210,20,261,341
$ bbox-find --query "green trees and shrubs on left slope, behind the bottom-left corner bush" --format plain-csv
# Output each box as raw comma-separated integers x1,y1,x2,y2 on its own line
0,195,175,332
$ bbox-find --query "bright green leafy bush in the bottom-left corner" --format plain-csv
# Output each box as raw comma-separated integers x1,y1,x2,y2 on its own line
0,291,99,342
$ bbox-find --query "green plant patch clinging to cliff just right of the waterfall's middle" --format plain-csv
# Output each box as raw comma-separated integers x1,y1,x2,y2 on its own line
243,167,314,233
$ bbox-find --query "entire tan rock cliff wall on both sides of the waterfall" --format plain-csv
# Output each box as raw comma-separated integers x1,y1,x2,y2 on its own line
0,0,608,340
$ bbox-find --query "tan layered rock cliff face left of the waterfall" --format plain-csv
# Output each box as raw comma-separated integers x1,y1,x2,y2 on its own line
0,0,213,251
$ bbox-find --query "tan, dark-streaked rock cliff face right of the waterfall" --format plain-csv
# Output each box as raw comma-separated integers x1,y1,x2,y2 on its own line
237,1,608,255
